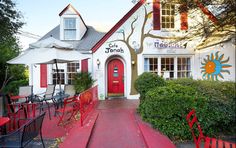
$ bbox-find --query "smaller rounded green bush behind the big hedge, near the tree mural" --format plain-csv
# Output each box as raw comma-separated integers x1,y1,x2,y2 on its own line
134,72,166,100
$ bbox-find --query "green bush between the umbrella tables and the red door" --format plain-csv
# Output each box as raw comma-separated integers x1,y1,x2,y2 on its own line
74,72,94,93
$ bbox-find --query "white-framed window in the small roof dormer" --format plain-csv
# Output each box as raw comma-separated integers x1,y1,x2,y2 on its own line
64,18,76,40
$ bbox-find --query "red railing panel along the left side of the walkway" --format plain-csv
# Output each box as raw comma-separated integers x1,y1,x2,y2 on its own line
79,86,98,126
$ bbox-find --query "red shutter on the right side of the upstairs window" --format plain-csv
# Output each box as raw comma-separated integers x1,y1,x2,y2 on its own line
180,4,188,30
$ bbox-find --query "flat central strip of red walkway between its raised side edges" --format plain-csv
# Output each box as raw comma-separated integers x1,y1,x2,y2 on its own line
88,109,146,148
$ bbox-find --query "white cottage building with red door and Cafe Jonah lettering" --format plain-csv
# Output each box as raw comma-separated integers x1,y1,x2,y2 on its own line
27,0,235,100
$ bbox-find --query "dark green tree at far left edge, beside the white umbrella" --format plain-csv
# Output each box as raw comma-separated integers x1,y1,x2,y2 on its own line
0,0,26,92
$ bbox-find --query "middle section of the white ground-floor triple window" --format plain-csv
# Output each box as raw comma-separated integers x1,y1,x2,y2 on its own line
161,58,174,78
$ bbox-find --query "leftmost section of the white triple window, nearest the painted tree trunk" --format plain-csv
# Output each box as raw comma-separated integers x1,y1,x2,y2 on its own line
144,58,158,74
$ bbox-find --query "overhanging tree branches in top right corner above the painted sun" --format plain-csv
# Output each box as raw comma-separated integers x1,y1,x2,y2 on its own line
172,0,236,39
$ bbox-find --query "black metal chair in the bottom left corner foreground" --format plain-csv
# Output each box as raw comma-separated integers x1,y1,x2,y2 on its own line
0,112,45,148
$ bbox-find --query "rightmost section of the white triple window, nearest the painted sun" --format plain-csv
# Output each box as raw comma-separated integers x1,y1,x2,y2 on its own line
177,58,191,78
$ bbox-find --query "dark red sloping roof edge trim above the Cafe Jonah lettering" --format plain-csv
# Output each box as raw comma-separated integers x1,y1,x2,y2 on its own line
92,0,145,52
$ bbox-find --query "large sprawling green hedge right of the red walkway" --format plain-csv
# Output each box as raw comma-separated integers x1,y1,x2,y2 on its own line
138,79,236,141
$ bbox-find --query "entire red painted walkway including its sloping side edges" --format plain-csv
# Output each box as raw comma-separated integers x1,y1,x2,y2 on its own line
59,99,175,148
